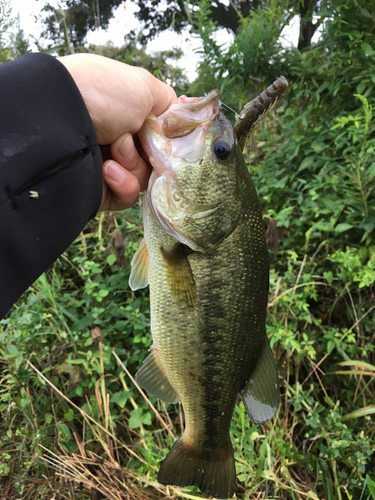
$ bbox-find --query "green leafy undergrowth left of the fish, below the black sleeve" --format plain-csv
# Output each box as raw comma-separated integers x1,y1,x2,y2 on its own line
0,209,154,488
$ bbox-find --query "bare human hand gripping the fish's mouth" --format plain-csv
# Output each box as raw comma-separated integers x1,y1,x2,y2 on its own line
59,54,177,211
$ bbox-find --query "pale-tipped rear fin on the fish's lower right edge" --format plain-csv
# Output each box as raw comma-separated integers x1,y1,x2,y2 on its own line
240,338,279,424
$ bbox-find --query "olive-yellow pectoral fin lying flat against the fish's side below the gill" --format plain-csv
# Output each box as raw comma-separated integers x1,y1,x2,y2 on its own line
161,245,196,307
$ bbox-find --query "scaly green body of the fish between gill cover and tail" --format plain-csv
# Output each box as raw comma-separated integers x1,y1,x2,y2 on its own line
145,196,268,452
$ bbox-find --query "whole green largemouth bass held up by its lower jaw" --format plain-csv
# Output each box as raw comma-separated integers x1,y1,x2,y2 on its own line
129,85,279,499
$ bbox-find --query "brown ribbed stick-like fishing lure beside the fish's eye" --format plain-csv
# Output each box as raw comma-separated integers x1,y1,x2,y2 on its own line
234,76,288,149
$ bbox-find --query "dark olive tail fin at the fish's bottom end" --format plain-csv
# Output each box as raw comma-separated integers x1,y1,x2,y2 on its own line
158,436,236,498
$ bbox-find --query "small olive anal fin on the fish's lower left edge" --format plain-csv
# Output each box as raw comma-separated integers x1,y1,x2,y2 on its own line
135,350,180,403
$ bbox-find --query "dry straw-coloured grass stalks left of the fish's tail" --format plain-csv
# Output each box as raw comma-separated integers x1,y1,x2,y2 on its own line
22,353,210,500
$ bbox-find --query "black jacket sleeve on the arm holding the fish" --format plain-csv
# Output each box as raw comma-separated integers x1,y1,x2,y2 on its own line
0,53,103,318
